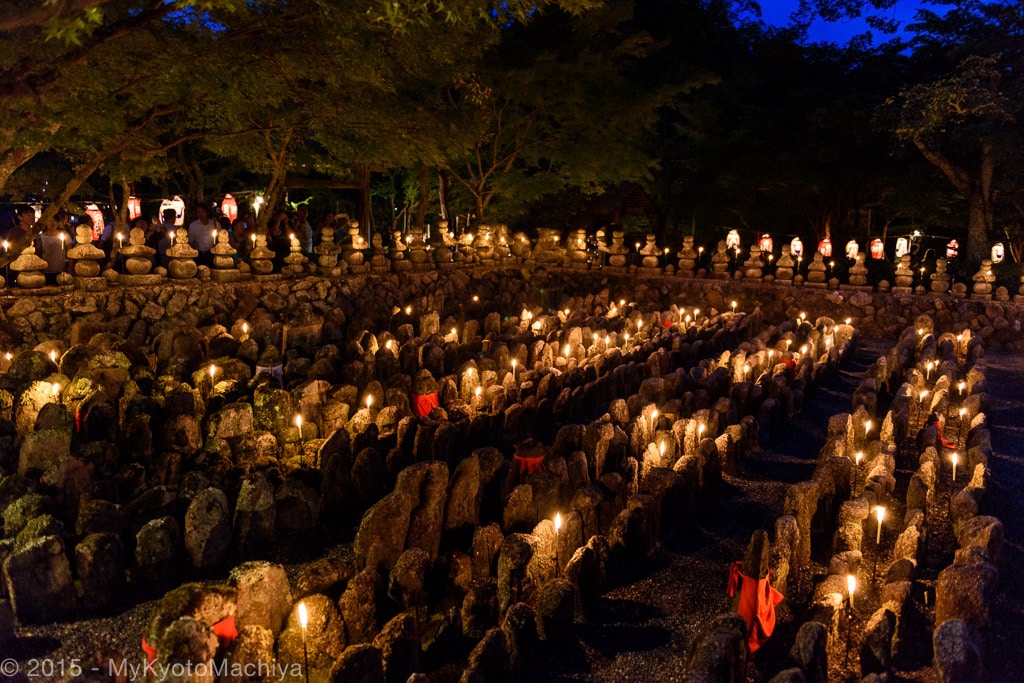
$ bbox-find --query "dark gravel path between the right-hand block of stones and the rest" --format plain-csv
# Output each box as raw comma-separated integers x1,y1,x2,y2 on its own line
538,340,889,683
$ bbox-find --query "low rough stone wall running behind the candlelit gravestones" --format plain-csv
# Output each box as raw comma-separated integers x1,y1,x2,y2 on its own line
0,268,1024,351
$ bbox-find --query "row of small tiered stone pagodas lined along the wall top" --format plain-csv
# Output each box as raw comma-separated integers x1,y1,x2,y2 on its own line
0,221,1024,299
